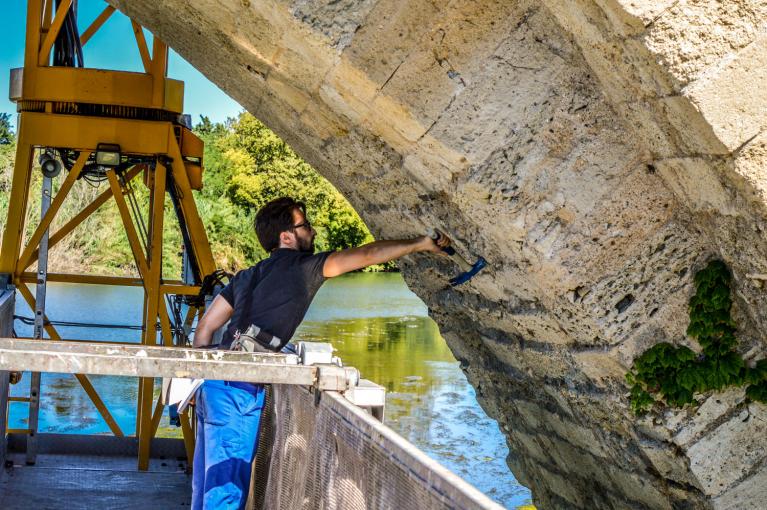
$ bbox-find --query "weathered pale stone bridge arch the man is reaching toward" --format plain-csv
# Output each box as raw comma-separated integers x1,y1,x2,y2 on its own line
109,0,767,508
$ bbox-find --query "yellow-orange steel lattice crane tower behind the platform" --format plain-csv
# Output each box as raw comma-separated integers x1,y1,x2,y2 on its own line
0,0,216,470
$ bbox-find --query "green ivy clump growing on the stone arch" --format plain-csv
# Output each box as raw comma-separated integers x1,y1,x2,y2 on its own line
626,260,767,415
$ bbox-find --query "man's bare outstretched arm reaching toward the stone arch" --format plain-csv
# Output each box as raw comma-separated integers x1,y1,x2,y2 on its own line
322,236,450,278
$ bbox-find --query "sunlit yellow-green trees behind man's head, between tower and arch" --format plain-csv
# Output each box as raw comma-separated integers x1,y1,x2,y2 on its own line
195,113,380,269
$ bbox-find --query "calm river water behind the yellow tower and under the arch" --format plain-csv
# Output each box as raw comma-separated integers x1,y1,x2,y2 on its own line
10,273,530,508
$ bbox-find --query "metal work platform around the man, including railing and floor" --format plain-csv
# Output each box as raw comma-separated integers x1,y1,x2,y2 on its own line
0,291,508,510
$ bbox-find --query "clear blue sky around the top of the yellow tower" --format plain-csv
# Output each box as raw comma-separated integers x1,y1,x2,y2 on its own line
0,0,242,123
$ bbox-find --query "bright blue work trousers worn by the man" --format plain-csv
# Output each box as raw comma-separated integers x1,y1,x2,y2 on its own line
192,381,264,510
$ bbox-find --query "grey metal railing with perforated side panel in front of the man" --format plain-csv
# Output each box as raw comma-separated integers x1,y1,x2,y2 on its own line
0,304,501,510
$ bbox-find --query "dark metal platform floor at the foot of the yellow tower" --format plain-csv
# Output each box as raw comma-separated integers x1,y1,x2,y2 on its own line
0,434,192,510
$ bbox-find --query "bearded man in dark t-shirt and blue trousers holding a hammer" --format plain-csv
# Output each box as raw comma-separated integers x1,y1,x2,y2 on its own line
192,198,450,510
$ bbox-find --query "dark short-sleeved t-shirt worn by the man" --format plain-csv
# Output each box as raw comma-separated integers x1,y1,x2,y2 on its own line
220,248,332,347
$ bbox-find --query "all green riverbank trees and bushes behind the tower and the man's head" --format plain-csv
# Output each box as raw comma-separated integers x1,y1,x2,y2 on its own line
0,113,382,278
